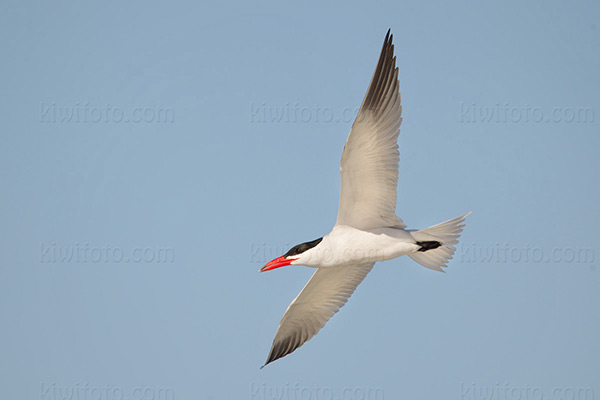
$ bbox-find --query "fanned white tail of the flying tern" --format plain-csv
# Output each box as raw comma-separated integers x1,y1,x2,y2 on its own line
408,211,471,272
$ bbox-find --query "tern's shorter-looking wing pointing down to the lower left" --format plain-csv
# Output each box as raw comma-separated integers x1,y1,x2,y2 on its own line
263,263,374,367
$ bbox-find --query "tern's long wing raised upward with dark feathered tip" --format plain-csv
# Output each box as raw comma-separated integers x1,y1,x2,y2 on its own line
337,31,406,229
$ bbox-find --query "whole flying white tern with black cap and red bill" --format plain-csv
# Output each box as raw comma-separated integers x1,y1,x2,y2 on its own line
260,30,470,368
